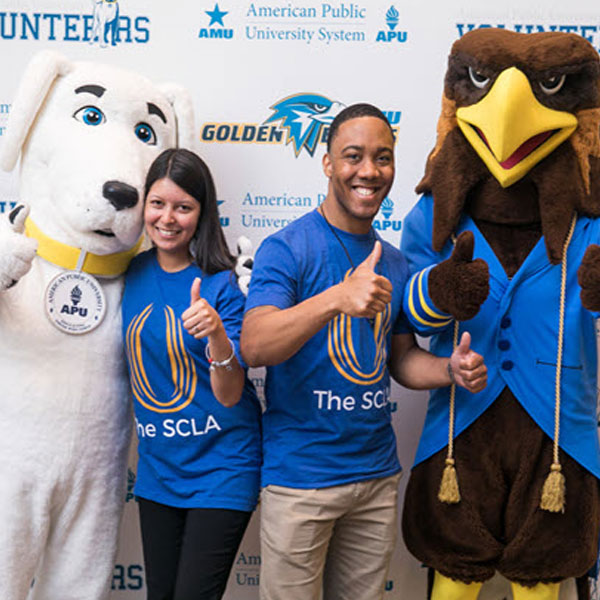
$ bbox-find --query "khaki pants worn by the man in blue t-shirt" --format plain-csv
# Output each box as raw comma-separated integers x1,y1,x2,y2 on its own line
260,473,400,600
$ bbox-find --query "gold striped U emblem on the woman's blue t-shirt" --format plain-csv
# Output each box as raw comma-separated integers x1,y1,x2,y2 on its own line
125,304,198,413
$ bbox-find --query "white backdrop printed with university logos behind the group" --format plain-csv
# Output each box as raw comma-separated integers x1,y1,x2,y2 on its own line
0,0,600,600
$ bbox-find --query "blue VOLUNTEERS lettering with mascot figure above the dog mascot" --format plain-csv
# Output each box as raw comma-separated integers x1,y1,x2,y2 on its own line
0,0,150,48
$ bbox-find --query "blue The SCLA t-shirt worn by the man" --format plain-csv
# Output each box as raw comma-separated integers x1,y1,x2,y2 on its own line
246,211,409,488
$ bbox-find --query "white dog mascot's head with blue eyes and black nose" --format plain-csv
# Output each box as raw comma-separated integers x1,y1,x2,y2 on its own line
0,51,194,255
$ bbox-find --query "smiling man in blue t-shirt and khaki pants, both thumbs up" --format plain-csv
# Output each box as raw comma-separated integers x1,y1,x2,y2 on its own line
241,104,486,600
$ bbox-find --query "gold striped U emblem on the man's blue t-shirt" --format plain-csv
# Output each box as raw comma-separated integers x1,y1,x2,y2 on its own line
327,269,391,385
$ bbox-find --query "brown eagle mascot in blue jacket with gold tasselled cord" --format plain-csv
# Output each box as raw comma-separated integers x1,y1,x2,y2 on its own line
402,29,600,600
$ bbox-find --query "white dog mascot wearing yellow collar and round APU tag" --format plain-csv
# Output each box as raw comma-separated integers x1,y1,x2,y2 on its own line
0,52,194,600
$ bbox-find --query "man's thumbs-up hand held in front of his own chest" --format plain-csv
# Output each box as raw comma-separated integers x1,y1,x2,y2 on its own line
338,240,392,319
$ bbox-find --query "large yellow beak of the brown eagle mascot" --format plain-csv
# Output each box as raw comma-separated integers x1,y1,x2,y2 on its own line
456,67,577,187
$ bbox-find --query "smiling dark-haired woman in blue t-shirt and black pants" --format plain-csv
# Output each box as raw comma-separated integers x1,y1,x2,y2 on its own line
123,149,260,600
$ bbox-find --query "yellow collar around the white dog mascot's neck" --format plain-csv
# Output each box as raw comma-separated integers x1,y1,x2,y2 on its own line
25,218,142,277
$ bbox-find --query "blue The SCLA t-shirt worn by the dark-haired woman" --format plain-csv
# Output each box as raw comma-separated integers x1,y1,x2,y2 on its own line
122,250,261,511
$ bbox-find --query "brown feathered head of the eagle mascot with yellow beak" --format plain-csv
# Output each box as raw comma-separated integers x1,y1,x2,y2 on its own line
417,29,600,264
